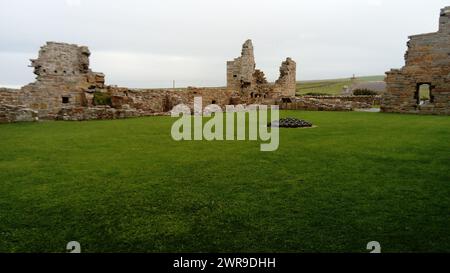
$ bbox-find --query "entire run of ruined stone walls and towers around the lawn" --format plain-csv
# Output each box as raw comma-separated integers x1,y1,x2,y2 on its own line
0,4,450,122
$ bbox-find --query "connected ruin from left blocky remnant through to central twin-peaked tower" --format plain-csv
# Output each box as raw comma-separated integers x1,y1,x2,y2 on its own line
0,40,295,122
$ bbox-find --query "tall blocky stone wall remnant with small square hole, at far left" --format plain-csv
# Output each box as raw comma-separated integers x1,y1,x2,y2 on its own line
20,42,104,119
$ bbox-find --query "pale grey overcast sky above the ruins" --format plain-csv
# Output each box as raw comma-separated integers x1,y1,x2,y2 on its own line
0,0,450,87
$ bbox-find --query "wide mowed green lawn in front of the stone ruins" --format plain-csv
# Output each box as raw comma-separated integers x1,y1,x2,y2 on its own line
0,111,450,253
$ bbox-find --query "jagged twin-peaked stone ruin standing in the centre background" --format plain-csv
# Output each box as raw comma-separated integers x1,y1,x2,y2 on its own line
227,40,297,103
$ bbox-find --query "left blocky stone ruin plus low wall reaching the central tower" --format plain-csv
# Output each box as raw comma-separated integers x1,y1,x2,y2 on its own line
0,42,241,122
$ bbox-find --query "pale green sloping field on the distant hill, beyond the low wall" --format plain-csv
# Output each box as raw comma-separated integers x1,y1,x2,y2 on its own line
297,75,384,95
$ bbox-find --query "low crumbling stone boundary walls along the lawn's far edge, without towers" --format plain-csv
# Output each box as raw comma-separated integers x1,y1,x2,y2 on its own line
0,87,381,123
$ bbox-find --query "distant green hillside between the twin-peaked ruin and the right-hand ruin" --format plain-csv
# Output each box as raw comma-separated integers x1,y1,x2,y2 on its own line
297,75,384,95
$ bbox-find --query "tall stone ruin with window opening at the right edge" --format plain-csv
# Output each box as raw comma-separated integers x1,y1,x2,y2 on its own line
381,7,450,115
